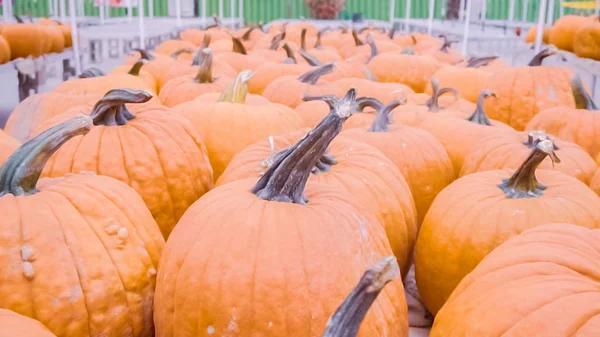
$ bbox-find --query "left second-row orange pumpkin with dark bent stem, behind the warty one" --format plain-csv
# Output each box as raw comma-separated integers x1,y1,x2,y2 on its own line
34,89,213,238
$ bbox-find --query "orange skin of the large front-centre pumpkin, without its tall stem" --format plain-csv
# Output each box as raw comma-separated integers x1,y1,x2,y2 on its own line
154,179,408,337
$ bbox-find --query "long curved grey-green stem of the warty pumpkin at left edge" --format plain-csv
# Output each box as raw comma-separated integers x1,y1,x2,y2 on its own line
0,115,93,196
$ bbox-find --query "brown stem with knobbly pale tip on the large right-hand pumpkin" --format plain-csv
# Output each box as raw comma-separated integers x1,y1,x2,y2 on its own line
498,138,560,199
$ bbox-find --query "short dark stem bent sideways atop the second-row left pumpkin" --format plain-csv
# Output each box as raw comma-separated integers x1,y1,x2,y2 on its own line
90,89,152,126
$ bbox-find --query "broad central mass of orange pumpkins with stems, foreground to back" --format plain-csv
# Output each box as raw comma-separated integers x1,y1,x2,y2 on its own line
0,20,600,337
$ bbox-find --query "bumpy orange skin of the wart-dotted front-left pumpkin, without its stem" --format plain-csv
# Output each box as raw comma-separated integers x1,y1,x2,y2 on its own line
0,174,164,337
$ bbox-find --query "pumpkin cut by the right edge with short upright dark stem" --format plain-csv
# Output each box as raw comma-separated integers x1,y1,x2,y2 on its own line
526,75,600,158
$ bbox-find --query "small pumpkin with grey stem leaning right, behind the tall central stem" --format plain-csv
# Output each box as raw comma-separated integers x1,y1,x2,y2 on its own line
263,63,341,109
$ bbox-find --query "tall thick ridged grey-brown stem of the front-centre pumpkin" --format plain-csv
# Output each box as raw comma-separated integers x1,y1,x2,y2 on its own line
252,89,358,204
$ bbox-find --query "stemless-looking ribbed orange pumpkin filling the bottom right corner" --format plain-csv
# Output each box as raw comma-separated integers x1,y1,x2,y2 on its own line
430,224,600,337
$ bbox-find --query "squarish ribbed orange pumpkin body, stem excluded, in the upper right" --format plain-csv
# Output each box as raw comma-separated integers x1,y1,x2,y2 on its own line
485,66,575,131
